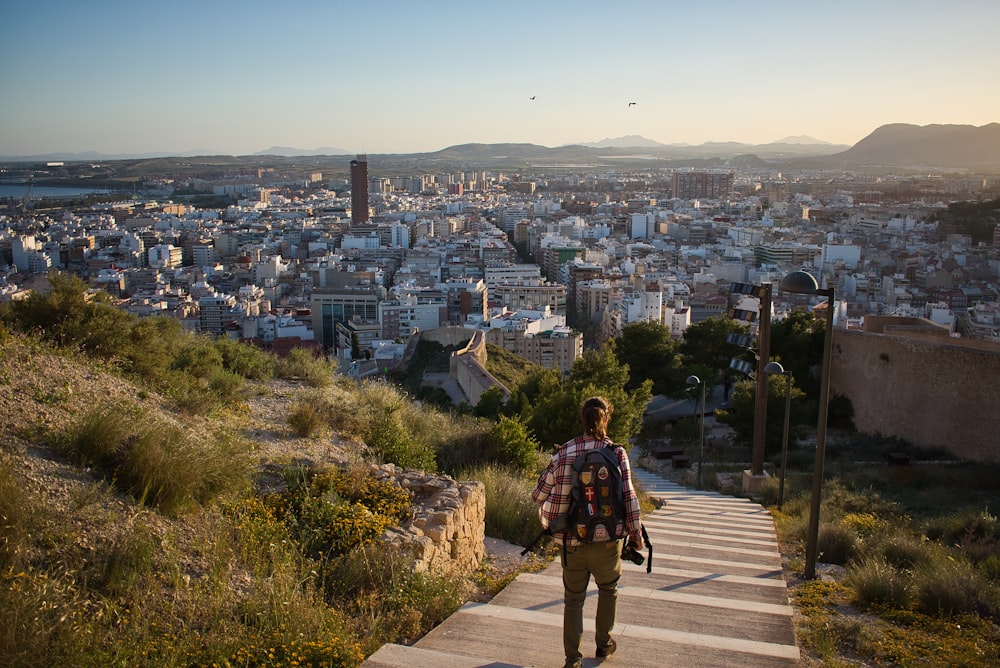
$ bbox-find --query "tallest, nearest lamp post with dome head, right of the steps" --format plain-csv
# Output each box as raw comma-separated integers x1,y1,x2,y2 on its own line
778,271,834,580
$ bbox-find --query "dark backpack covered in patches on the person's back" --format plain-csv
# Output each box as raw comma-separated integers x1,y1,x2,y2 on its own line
564,443,627,543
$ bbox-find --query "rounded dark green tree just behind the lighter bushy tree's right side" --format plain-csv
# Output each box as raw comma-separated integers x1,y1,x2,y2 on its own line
613,322,683,395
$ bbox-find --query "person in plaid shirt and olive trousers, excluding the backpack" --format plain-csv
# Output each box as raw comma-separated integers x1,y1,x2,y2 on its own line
531,397,643,668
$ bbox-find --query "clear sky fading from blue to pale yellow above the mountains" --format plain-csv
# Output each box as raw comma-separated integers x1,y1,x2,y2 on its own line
0,0,1000,156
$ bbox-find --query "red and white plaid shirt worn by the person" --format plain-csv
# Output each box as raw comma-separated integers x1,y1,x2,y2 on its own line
531,436,642,545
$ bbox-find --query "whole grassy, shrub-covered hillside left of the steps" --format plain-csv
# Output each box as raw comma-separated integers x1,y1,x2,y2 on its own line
0,276,537,666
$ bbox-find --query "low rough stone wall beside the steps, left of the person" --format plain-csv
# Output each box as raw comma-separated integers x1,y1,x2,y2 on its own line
375,464,486,573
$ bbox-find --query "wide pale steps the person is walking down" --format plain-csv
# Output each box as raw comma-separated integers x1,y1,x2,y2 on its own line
362,468,800,668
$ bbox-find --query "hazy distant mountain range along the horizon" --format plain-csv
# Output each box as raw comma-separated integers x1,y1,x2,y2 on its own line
0,123,1000,170
